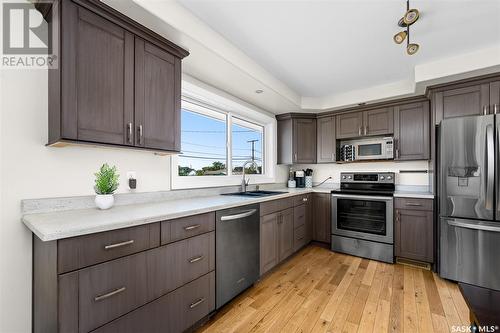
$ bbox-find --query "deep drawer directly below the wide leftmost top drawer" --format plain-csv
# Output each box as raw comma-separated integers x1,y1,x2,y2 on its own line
78,252,148,332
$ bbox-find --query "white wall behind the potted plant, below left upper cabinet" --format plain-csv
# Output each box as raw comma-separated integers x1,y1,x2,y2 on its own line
0,70,177,333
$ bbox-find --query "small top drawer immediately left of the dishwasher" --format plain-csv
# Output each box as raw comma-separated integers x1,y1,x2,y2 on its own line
161,212,215,245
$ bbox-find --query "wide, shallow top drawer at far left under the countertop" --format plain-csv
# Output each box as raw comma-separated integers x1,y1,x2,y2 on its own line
57,223,160,273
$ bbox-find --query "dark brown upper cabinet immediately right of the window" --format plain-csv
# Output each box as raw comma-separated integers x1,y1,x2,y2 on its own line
276,113,316,164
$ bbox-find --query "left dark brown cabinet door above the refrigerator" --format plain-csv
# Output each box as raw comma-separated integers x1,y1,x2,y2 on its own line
433,84,490,123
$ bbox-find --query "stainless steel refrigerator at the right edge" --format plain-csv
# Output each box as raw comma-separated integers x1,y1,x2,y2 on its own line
439,115,500,290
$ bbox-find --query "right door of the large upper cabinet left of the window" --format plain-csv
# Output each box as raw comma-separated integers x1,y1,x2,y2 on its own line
135,38,181,151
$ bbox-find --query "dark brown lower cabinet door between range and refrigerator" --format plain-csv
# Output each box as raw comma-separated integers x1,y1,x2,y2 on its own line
395,209,434,262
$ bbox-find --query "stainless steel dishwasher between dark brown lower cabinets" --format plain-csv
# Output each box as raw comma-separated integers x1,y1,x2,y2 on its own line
215,204,260,309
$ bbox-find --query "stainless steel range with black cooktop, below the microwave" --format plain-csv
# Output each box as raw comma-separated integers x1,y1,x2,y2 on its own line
331,172,394,263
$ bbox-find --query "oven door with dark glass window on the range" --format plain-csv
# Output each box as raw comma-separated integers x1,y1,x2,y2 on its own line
332,194,394,244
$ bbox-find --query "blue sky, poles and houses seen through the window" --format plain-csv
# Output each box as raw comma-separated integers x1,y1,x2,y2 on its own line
178,103,264,176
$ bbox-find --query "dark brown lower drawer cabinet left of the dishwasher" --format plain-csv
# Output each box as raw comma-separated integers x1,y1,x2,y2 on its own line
33,213,216,333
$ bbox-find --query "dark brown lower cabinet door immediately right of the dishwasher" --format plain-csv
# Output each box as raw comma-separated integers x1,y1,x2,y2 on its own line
260,213,279,275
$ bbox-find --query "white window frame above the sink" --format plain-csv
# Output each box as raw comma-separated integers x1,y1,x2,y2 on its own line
171,81,276,189
